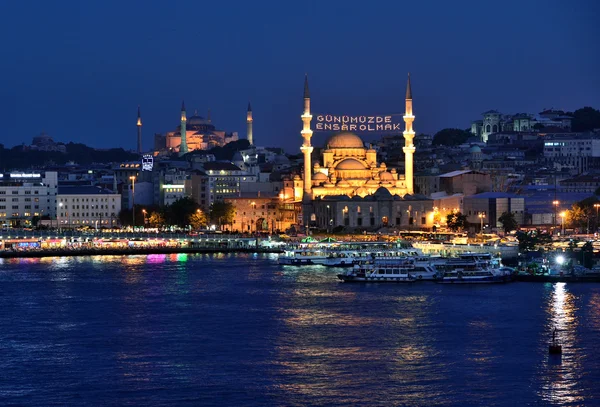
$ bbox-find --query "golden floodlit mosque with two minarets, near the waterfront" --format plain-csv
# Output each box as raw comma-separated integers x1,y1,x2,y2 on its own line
292,75,433,228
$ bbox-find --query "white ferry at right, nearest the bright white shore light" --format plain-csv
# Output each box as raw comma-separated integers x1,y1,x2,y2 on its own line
437,259,511,284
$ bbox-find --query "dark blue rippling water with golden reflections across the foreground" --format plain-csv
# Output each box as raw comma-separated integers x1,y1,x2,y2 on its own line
0,255,600,406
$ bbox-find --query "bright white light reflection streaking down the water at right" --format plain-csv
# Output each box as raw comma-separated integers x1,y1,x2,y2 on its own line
539,283,584,405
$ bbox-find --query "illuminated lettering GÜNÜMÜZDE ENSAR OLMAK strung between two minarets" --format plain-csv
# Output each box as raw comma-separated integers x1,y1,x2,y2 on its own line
315,114,404,132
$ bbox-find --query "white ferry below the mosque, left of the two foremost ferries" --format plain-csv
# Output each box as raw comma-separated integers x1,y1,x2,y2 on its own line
337,261,417,283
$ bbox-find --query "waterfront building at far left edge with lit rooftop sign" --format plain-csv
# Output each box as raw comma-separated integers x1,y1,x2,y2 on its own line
0,171,58,227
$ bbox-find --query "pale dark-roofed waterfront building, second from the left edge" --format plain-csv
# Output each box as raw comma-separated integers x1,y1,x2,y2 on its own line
56,186,121,229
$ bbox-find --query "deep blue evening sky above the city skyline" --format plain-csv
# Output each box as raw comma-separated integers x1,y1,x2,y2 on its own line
0,0,600,152
